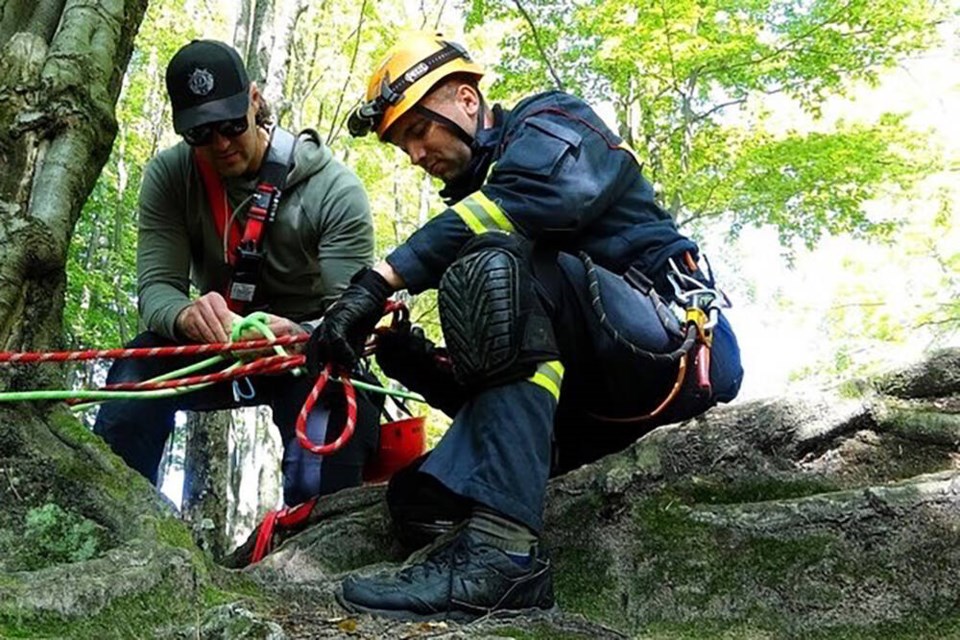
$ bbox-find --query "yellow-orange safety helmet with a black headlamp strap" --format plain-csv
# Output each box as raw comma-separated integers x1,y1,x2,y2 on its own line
347,32,483,140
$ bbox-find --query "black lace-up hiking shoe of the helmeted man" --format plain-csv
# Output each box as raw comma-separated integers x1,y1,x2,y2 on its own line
337,528,554,622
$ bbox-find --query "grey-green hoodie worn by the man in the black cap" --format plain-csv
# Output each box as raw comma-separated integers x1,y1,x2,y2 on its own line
137,130,374,339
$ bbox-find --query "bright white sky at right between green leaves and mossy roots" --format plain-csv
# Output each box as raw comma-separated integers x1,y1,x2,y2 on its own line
728,28,960,400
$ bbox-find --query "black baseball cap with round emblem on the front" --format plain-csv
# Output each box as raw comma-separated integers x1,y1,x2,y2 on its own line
167,40,250,133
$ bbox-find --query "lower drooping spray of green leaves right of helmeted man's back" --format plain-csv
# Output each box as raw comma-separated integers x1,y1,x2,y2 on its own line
696,114,932,247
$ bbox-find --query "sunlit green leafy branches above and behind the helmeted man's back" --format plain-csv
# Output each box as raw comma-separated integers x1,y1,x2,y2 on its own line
468,0,947,247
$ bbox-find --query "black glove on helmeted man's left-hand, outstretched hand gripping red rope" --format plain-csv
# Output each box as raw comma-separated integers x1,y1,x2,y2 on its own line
307,268,393,376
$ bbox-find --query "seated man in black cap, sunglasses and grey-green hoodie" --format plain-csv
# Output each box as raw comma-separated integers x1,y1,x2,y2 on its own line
94,40,379,504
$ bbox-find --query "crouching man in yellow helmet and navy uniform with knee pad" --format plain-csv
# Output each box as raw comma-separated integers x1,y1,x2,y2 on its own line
307,34,742,619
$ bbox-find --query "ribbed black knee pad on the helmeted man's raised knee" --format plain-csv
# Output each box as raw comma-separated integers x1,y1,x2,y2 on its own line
437,233,559,389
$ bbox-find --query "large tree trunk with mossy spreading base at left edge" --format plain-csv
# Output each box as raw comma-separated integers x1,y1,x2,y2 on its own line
0,0,218,637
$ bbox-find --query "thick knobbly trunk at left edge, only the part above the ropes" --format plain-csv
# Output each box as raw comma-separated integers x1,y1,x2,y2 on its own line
0,0,146,381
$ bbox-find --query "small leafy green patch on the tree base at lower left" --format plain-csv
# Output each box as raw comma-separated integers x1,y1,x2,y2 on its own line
7,502,100,571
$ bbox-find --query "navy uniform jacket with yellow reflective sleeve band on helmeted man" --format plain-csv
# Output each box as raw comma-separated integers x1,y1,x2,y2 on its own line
387,91,697,293
